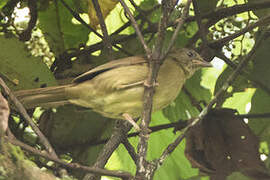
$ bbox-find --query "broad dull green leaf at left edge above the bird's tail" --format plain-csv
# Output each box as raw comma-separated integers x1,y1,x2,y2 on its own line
0,36,57,90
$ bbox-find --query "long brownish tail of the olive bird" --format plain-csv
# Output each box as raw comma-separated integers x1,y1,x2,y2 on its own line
14,84,72,109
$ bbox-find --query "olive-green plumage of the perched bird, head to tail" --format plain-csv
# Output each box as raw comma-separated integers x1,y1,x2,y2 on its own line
15,48,211,119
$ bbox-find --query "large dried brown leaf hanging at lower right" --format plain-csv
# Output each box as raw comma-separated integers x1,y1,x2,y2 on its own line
185,109,270,180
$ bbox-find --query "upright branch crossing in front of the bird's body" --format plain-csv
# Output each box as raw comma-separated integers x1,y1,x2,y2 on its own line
136,0,176,179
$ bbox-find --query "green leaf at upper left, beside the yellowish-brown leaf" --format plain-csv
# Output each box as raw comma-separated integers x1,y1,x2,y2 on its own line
39,1,90,56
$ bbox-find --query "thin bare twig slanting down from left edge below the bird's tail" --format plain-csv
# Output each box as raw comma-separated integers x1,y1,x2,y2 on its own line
0,78,58,158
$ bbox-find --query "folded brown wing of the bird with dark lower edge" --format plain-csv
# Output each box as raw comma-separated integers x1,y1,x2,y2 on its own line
72,56,147,83
